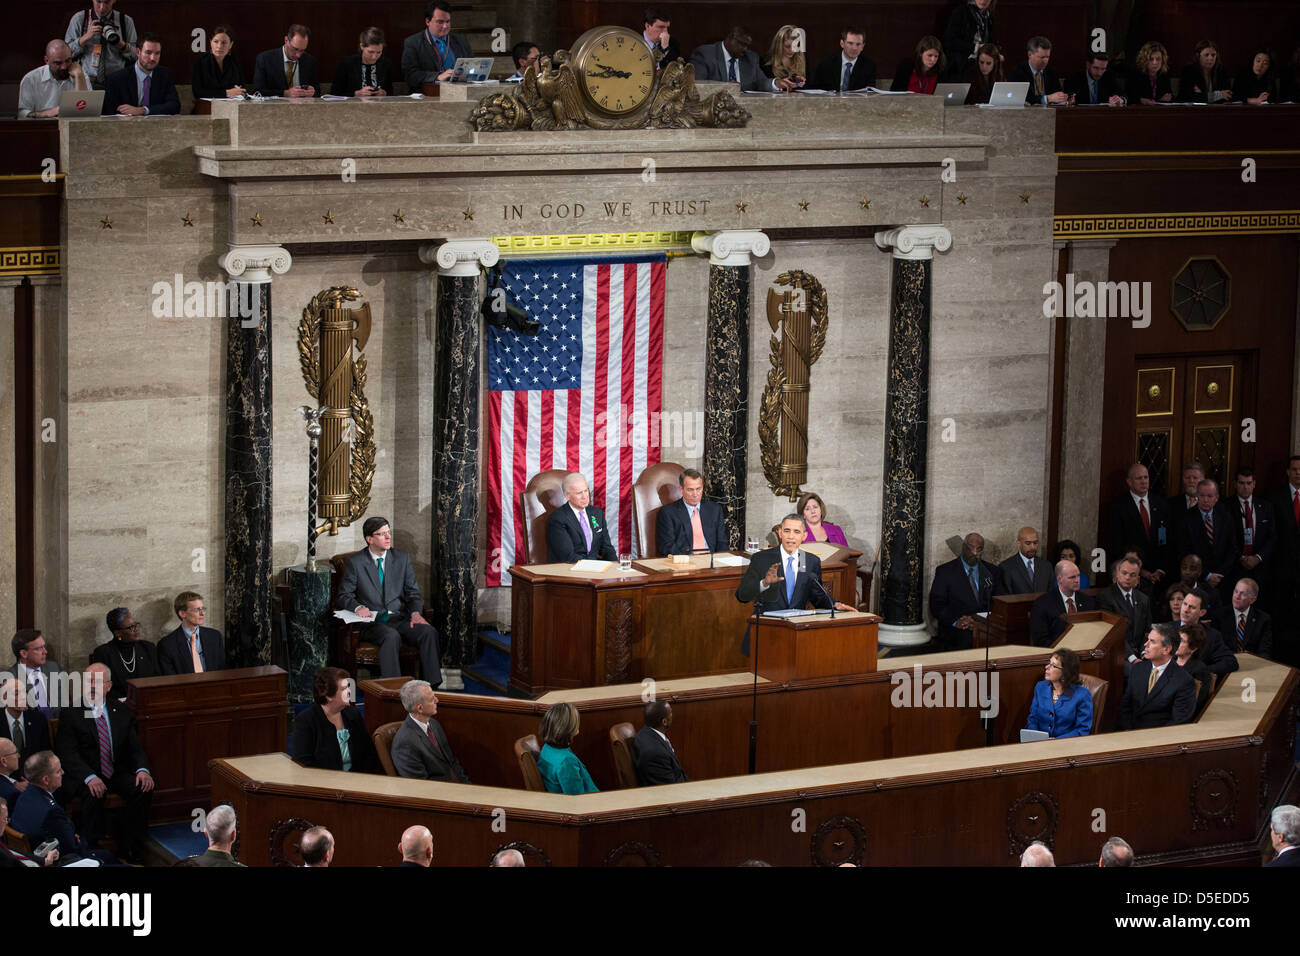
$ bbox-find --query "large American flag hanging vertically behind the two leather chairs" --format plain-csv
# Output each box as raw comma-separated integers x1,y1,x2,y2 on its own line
486,255,667,585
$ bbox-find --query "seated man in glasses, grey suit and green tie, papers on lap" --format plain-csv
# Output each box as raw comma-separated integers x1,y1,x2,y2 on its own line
338,515,442,687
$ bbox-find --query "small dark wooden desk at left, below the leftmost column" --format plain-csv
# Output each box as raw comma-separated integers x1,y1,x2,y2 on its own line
126,666,289,822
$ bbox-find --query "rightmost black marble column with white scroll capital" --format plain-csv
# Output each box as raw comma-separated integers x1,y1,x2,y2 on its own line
876,225,953,646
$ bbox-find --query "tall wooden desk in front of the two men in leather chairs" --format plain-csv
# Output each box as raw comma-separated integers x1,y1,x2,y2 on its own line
510,548,862,697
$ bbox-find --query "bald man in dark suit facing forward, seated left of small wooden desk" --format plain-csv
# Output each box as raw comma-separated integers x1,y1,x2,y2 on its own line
55,663,153,862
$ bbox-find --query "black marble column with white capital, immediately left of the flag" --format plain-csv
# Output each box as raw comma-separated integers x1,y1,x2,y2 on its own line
420,239,499,671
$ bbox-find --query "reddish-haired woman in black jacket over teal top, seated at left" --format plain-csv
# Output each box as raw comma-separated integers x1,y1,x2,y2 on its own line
289,667,384,774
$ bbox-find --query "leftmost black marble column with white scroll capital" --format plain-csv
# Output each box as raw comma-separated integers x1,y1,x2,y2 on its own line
218,246,293,667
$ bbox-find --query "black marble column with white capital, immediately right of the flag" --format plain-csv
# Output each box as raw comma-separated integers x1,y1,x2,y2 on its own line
690,230,771,550
